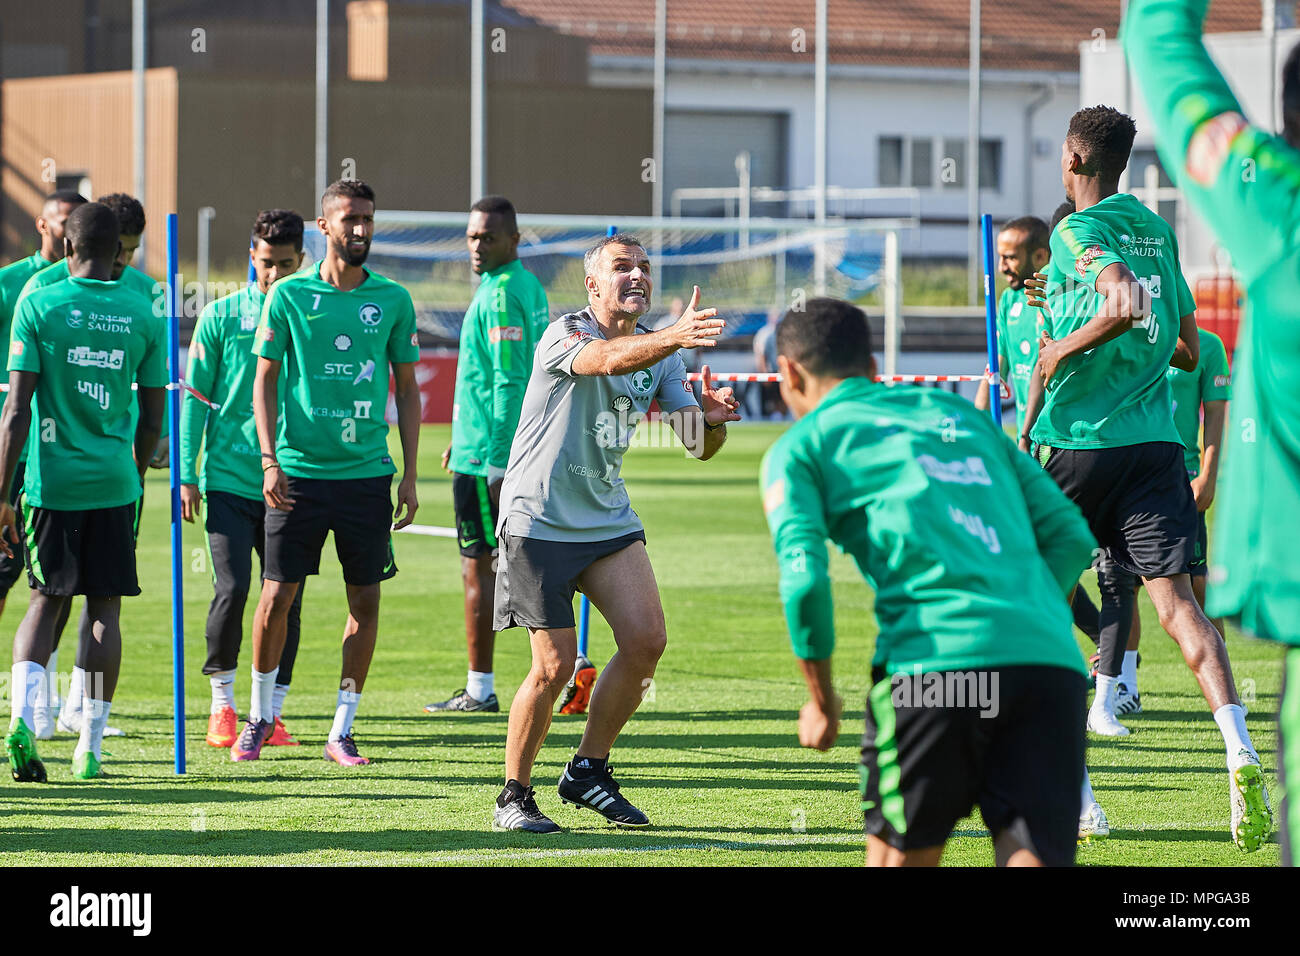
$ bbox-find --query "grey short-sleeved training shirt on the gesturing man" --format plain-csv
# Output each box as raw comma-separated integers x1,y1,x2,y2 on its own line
497,308,698,541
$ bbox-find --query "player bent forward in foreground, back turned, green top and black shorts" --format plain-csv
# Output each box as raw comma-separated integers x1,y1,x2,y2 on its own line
762,299,1095,866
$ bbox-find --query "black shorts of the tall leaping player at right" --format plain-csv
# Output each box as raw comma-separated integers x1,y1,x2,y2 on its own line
1039,441,1197,578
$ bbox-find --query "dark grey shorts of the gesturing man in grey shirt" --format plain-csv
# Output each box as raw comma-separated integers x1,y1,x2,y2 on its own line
491,531,646,631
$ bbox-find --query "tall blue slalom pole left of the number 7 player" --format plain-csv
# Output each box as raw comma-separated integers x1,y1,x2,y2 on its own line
166,212,185,774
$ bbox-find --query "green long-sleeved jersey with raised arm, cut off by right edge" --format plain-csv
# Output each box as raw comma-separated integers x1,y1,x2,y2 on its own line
1121,0,1300,645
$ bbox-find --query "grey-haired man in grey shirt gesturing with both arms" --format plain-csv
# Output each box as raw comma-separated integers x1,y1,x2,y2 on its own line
493,234,740,834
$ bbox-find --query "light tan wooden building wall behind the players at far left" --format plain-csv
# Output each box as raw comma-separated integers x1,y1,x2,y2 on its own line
0,69,177,276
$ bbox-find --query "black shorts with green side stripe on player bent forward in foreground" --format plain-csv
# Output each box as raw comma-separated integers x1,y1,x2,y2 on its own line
861,666,1084,866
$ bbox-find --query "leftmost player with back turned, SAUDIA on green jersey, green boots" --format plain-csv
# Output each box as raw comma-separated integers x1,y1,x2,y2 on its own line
0,203,166,782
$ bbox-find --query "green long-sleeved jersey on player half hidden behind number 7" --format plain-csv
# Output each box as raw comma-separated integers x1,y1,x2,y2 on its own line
181,284,265,501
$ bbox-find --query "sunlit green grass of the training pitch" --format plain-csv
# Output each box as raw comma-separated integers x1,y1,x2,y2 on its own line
0,425,1281,866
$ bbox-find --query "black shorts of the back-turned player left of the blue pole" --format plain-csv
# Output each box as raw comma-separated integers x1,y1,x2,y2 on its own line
22,496,140,597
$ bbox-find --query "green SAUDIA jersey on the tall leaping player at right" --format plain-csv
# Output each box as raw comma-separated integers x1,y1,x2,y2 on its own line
1032,193,1196,449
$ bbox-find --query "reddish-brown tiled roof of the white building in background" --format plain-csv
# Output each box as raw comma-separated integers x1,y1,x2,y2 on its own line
502,0,1260,73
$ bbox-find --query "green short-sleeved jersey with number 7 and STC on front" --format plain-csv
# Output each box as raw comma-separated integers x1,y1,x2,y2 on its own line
254,263,420,479
